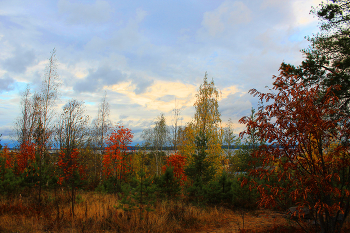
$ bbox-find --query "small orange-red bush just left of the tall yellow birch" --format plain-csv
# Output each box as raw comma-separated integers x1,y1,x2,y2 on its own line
163,153,187,185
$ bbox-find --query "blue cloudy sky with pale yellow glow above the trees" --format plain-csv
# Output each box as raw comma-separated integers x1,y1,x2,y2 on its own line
0,0,321,146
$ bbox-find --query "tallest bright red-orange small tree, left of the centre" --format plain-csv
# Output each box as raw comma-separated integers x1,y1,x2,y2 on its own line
103,126,134,180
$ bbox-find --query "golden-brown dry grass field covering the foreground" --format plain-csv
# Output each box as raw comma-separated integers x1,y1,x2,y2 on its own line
0,192,349,233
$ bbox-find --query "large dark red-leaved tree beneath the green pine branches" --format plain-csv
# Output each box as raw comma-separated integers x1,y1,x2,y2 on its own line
240,63,350,226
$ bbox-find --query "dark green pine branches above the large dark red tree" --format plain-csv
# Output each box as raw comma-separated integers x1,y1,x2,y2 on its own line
284,0,350,111
